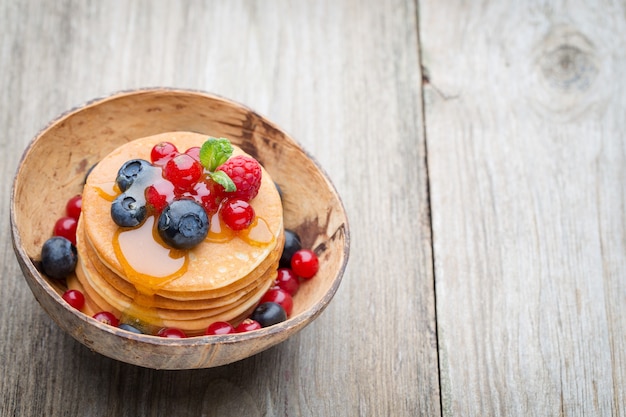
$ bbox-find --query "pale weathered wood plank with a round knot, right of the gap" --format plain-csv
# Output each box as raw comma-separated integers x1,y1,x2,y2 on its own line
420,0,626,416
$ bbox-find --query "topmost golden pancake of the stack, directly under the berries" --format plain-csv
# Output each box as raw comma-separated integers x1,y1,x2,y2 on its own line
81,132,283,292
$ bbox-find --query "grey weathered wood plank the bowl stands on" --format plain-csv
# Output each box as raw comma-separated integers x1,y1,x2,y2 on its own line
0,0,440,416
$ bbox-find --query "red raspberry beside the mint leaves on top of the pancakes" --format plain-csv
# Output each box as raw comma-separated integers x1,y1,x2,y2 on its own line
217,155,261,201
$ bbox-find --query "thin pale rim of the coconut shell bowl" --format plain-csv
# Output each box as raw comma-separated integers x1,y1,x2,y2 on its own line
9,87,350,347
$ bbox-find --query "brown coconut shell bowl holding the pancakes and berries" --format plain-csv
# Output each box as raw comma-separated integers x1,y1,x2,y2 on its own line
10,89,349,369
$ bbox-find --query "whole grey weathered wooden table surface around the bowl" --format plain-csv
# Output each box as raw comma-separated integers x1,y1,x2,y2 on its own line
0,0,626,416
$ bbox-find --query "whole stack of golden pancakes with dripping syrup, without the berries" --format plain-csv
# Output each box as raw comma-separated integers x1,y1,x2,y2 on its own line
68,132,284,335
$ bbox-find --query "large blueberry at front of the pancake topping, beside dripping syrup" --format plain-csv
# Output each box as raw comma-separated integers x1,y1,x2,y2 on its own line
157,200,209,249
